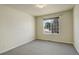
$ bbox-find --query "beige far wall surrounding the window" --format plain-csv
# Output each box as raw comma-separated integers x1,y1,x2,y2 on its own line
36,10,73,43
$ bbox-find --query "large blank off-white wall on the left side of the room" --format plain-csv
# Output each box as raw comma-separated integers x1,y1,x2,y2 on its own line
0,5,35,53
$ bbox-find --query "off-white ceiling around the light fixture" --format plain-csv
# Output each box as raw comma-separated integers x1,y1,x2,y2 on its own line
6,4,74,16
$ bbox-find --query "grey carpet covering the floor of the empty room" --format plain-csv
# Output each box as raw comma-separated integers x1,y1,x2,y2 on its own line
2,40,78,55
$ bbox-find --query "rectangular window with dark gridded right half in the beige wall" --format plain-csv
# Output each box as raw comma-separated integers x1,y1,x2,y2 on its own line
43,17,59,34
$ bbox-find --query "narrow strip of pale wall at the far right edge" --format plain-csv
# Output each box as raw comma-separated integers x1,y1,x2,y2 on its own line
73,5,79,52
